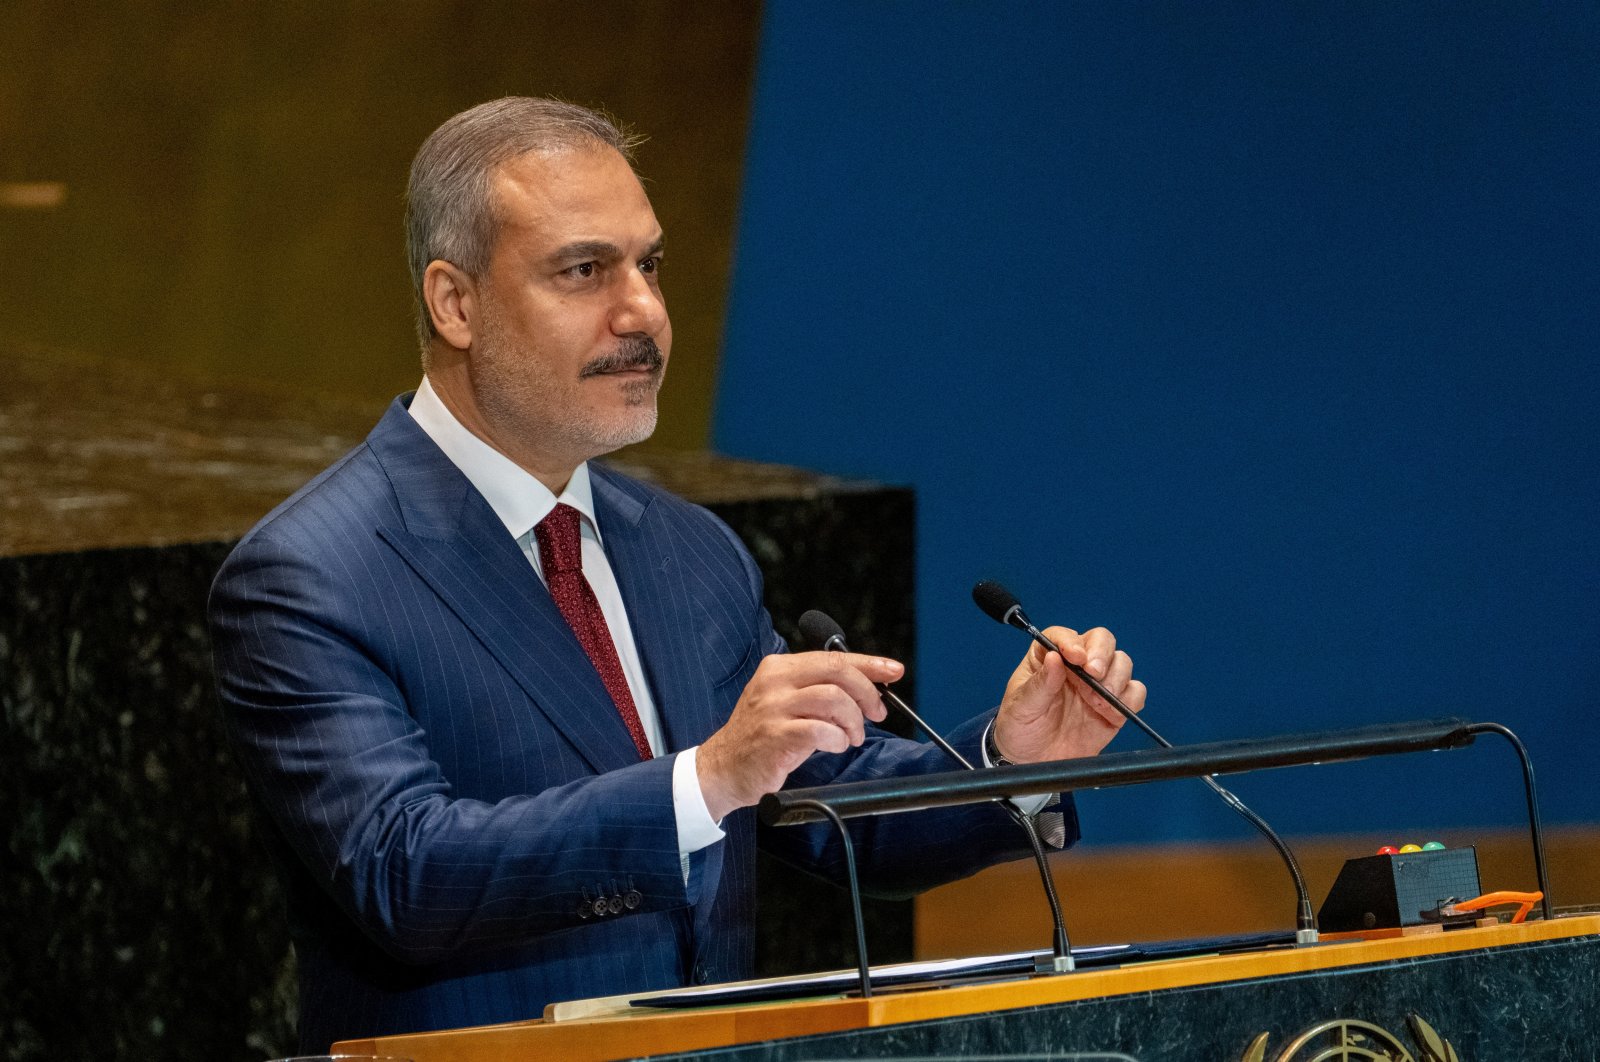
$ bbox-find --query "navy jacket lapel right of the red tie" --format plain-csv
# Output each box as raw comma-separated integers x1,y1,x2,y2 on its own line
589,464,722,752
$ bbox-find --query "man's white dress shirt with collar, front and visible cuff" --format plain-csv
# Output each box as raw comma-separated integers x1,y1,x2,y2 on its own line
410,376,725,881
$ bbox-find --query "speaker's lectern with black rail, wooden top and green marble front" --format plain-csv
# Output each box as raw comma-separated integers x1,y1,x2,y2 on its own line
336,718,1600,1062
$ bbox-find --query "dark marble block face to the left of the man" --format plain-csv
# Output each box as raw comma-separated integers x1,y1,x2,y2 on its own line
0,544,293,1060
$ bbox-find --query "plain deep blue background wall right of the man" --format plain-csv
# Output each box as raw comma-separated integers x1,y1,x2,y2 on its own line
714,0,1600,841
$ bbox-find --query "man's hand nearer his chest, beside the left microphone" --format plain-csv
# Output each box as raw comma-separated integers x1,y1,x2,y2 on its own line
694,653,906,822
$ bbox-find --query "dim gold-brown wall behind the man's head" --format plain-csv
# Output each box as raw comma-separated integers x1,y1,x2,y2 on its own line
0,0,760,448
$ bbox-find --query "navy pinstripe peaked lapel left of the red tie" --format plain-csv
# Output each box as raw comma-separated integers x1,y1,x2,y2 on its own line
366,398,643,773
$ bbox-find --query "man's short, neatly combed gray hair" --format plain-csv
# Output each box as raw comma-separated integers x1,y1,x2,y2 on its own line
405,96,643,350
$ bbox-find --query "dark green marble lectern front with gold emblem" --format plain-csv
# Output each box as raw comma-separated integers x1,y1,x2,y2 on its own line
651,936,1600,1062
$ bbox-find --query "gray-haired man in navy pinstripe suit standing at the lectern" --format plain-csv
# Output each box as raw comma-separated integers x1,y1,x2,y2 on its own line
211,99,1144,1049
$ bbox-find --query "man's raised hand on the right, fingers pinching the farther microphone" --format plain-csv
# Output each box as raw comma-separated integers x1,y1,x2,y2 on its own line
994,627,1146,763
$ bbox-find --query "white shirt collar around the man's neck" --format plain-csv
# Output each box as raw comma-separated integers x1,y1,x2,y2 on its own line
410,376,600,539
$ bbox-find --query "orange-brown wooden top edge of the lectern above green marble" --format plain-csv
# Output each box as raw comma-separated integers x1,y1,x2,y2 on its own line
334,915,1600,1062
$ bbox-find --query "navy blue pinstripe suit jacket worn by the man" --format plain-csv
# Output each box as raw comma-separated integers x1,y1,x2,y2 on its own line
211,398,1075,1051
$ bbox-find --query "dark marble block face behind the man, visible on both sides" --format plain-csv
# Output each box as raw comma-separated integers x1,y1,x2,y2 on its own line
0,489,914,1062
